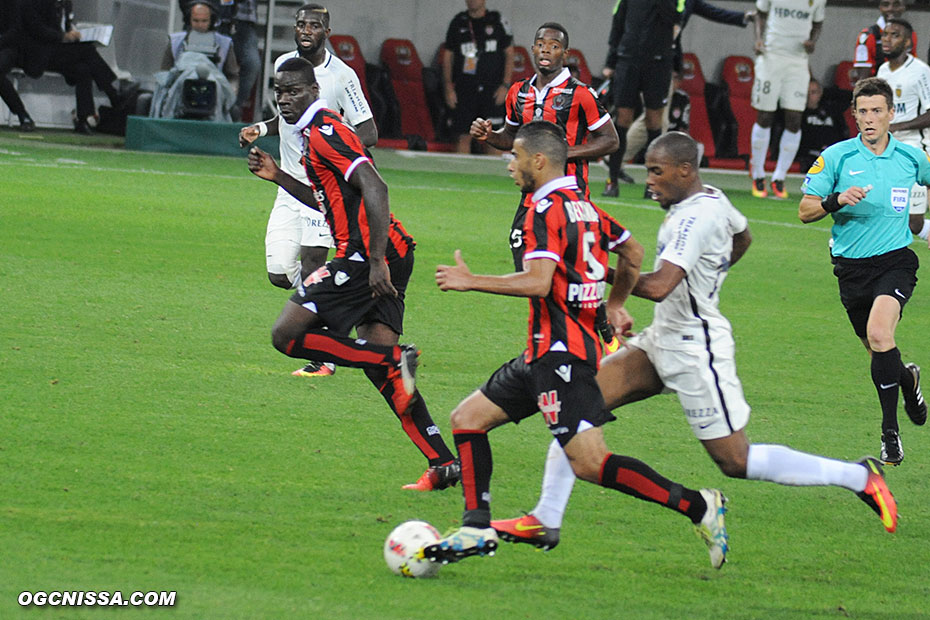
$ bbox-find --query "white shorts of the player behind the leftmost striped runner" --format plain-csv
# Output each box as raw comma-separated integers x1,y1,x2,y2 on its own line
265,185,333,282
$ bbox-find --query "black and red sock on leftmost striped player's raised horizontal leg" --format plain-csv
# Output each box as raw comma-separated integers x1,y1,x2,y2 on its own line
284,329,400,368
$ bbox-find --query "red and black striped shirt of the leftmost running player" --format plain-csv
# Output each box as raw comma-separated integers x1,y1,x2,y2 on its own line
297,99,415,262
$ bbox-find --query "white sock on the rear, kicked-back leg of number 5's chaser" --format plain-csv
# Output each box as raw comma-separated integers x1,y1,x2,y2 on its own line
746,444,869,493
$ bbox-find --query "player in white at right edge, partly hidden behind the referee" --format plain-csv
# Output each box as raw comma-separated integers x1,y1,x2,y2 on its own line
876,17,930,239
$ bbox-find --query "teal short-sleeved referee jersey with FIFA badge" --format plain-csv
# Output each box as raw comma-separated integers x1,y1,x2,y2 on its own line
801,134,930,258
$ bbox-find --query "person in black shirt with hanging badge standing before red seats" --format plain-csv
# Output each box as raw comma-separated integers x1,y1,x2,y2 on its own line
442,0,513,153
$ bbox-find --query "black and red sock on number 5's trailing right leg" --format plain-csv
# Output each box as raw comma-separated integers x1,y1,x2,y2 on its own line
598,454,707,523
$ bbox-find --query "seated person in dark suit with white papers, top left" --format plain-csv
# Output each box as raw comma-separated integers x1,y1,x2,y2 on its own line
20,0,125,134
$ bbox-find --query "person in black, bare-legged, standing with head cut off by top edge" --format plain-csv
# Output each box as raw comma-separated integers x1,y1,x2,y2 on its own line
601,0,684,196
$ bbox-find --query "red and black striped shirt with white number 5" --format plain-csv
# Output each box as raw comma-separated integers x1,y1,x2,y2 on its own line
523,176,631,367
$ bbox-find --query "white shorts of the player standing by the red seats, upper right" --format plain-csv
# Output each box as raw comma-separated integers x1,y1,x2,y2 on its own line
752,54,811,112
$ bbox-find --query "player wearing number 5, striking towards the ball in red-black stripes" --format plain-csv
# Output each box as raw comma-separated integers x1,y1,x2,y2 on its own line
422,121,726,562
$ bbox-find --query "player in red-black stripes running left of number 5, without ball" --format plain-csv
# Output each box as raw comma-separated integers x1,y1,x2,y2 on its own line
249,58,459,491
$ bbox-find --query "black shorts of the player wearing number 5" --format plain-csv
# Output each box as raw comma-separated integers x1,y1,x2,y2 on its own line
480,353,617,447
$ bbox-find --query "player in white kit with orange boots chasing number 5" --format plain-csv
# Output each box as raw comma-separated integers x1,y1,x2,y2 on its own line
491,132,897,548
